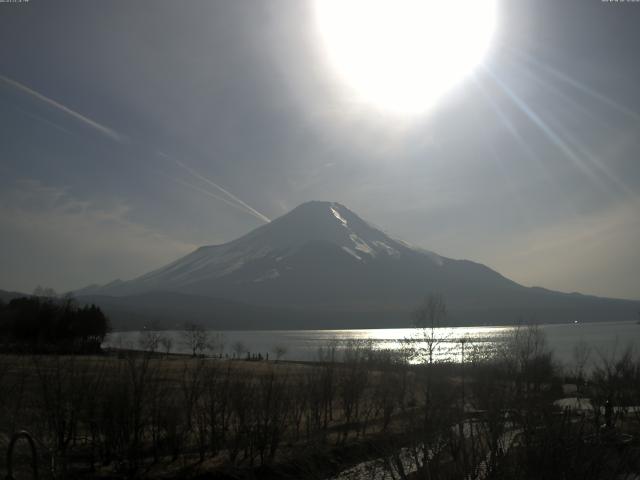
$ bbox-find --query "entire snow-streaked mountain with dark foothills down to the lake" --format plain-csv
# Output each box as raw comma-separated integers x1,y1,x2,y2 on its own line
75,201,640,329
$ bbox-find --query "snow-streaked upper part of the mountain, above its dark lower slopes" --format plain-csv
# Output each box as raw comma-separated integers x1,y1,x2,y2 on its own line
79,201,441,295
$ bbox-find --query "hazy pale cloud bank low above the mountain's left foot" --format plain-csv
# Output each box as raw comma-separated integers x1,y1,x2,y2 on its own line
0,180,196,291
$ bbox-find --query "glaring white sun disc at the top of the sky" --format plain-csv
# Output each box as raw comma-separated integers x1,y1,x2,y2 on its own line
315,0,496,114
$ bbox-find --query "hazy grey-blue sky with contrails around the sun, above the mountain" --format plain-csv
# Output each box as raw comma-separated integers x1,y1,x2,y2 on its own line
0,0,640,299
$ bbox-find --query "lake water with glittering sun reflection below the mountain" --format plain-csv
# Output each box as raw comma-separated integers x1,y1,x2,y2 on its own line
104,322,640,365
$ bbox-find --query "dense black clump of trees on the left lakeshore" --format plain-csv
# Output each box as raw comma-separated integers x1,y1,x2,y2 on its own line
0,296,109,353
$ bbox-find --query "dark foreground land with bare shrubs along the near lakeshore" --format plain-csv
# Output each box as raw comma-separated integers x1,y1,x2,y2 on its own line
0,329,640,479
